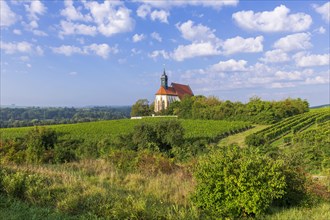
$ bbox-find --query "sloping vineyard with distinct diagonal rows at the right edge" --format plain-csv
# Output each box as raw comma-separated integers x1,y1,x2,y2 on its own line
245,108,330,146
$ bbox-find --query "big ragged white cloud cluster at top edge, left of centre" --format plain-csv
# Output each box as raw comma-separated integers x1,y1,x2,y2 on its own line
59,1,134,37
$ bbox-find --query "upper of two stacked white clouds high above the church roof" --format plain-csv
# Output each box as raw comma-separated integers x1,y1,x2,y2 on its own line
176,20,218,42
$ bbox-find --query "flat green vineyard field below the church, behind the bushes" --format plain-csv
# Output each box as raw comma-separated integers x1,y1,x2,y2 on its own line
0,118,252,142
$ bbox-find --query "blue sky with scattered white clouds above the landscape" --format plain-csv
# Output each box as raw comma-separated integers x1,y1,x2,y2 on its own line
0,0,330,107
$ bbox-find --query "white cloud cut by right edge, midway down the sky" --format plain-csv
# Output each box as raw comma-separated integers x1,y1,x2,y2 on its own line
293,52,330,67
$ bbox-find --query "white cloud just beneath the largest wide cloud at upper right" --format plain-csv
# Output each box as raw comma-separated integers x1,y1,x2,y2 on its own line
274,33,313,51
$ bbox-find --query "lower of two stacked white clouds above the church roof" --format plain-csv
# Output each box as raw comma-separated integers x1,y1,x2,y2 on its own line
171,42,220,61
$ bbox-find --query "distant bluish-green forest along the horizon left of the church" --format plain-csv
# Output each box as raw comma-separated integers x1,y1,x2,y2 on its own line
0,106,131,128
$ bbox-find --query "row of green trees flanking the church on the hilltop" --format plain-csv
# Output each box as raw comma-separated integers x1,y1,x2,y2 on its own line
131,96,309,124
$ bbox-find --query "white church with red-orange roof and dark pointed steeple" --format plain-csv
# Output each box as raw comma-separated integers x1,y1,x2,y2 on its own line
154,69,194,112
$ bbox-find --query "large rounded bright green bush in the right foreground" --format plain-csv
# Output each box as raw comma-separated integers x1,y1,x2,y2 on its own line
192,146,303,218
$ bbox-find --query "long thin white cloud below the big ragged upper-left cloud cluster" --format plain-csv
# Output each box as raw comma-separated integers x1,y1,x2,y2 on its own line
51,44,118,59
